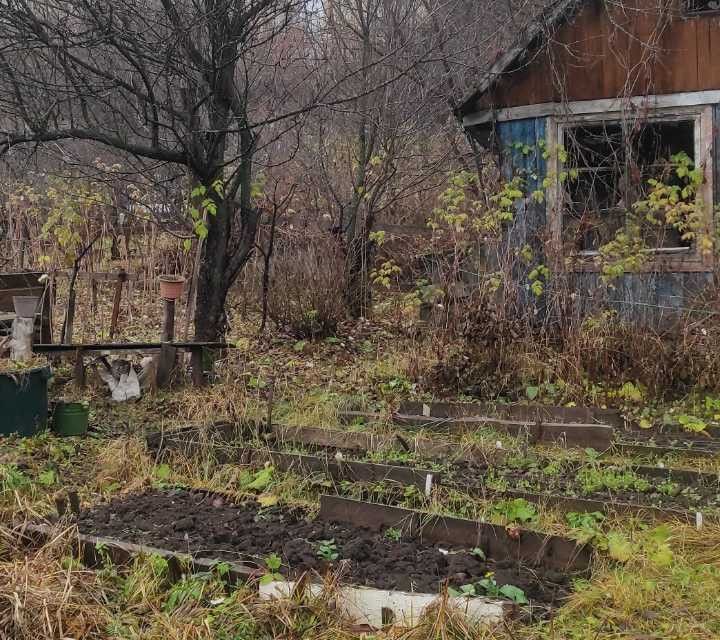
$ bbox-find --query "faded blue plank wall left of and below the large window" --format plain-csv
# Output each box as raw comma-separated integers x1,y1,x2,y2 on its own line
495,116,720,326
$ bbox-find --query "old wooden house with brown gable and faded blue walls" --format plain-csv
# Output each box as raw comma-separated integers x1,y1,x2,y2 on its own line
458,0,720,323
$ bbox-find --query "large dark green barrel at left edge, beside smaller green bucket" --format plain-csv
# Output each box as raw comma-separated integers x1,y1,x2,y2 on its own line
0,367,51,436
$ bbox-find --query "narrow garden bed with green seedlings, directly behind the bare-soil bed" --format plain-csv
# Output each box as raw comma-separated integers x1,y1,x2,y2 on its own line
149,428,720,522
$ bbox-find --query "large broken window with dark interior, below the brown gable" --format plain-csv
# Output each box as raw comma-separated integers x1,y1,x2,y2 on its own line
551,107,712,270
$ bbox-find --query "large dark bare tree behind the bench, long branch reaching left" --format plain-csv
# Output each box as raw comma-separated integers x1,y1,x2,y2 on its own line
0,0,302,340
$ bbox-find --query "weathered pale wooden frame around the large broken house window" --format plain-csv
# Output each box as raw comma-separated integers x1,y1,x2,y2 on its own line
547,103,714,272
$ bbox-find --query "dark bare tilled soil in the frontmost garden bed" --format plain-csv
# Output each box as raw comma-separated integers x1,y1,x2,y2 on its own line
78,489,571,604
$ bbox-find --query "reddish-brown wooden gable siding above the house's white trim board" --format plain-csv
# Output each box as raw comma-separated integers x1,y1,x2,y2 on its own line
466,0,720,113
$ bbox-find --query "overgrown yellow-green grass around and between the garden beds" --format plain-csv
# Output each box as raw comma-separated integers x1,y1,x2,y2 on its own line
0,308,720,640
